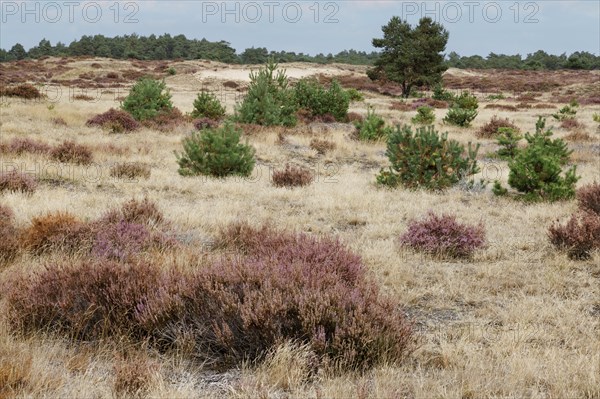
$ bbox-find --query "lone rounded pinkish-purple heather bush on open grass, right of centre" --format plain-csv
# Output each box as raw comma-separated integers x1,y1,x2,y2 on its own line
400,212,485,258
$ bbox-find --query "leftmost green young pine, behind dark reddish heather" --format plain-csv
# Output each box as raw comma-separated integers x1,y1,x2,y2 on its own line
121,78,173,121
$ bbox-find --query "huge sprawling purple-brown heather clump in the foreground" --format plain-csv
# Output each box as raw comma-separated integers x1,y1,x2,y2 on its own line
5,226,414,370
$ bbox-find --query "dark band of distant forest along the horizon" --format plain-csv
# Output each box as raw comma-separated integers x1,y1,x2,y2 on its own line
0,34,600,70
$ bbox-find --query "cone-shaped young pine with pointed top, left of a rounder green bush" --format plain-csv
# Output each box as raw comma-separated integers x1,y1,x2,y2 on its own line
235,60,298,126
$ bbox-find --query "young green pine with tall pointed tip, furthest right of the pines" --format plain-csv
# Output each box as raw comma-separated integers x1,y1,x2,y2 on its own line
494,117,579,202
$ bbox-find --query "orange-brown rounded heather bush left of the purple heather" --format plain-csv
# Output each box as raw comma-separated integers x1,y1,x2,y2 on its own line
22,212,93,255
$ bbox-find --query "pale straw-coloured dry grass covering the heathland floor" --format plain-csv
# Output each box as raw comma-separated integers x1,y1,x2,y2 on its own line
0,59,600,399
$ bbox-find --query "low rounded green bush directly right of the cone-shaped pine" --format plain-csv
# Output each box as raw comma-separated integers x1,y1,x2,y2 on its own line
294,79,350,121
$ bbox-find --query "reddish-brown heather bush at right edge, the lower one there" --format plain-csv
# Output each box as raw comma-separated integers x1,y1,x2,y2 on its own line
548,211,600,259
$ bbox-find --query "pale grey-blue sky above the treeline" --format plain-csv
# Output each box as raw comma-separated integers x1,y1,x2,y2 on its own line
0,0,600,56
